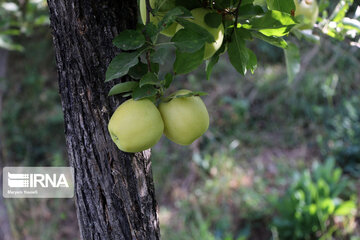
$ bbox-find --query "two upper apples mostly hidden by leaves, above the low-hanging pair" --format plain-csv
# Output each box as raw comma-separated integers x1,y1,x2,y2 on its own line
140,0,224,60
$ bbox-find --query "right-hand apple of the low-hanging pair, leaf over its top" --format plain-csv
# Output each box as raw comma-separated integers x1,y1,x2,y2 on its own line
159,89,209,145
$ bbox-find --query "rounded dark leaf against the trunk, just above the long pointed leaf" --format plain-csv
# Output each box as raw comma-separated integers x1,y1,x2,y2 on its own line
113,30,145,51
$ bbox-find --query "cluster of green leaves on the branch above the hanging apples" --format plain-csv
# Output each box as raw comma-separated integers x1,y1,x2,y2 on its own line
106,0,359,99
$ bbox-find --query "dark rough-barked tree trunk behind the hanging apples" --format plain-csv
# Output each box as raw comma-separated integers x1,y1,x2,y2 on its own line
48,0,160,240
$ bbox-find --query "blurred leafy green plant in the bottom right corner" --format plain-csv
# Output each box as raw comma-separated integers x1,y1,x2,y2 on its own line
273,160,357,240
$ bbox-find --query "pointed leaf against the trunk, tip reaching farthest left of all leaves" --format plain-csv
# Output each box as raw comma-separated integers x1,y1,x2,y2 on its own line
105,50,143,82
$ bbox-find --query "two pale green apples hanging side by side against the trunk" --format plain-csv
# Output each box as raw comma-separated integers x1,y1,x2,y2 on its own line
108,89,209,153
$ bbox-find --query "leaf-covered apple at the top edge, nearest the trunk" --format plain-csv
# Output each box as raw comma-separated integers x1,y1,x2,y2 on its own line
140,0,177,37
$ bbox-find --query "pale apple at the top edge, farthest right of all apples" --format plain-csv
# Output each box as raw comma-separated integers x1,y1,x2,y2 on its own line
294,0,319,29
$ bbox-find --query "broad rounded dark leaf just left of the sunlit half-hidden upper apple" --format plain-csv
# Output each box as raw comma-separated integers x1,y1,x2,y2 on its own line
171,29,206,52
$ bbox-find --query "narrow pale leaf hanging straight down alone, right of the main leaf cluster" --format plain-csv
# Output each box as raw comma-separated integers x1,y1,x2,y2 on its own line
284,43,300,82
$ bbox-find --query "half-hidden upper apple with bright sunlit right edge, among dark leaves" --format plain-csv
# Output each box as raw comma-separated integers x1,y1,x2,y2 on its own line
177,8,224,60
